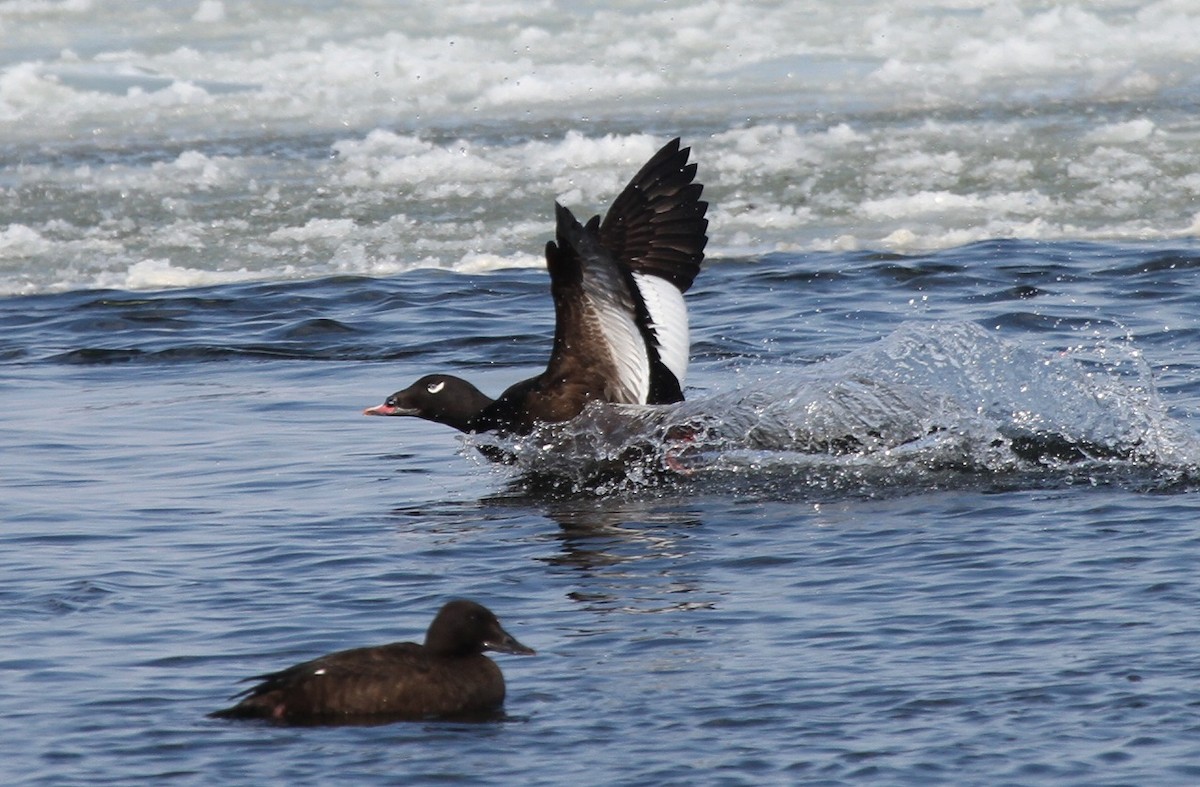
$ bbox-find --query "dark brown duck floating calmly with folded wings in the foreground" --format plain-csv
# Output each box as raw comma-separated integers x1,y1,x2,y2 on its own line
209,599,533,723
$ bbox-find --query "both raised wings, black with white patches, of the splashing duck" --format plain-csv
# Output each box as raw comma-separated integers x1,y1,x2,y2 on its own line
546,139,708,404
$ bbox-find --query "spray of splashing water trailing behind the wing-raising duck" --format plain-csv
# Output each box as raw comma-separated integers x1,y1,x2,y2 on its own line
467,323,1200,497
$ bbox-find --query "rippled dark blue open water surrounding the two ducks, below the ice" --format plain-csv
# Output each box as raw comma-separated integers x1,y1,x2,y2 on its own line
0,240,1200,785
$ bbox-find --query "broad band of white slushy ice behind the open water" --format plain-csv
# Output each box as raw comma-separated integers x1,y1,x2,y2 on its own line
0,0,1200,293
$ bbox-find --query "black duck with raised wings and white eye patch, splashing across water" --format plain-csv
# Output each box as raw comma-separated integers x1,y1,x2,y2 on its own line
364,138,708,434
